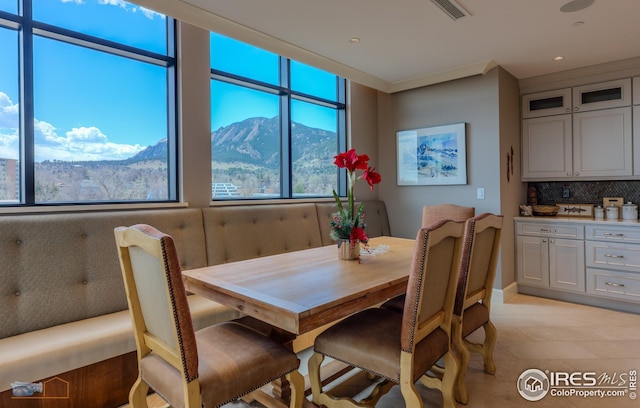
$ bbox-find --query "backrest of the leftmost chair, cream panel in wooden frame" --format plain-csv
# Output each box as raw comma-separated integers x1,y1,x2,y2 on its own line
114,224,198,382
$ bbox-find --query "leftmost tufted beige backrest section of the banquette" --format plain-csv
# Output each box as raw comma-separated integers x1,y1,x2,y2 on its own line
0,208,206,339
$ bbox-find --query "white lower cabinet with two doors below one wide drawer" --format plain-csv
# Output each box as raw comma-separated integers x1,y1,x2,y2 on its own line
516,222,585,293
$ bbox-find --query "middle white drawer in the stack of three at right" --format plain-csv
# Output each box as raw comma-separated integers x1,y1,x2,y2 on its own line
585,241,640,272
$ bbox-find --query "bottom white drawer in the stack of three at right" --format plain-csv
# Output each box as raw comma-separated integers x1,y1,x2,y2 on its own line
587,268,640,302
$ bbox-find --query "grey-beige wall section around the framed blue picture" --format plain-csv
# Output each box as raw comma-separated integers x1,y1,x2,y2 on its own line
378,68,525,289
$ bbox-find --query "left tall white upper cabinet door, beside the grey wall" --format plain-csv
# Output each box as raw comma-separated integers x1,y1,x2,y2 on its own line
522,115,572,180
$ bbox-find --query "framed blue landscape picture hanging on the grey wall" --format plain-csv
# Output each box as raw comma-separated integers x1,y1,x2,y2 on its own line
396,122,467,186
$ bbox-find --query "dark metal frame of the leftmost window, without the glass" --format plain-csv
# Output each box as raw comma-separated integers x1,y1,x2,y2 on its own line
0,0,181,207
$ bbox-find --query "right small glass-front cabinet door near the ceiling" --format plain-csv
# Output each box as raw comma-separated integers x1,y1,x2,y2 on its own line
573,78,631,112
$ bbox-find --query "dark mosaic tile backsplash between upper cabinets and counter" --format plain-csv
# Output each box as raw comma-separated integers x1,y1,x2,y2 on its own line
529,180,640,205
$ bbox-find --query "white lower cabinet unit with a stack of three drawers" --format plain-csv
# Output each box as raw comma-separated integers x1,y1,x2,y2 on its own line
585,226,640,302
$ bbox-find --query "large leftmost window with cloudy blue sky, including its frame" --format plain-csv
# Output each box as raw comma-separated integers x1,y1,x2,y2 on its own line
0,0,177,205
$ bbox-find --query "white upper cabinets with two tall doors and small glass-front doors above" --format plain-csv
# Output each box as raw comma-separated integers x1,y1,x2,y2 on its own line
522,78,640,181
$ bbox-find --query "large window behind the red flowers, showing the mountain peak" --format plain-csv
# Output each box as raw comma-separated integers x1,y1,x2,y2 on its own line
210,33,346,200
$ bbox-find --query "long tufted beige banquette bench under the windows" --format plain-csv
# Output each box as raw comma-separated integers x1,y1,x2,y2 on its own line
0,201,390,407
